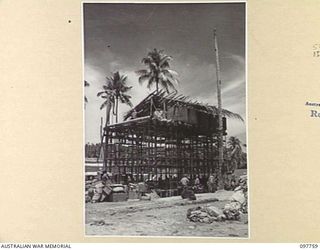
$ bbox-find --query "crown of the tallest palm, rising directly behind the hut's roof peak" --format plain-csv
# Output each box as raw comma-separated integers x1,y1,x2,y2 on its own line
136,49,178,93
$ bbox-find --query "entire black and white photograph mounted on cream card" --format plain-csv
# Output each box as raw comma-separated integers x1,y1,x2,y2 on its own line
82,2,250,238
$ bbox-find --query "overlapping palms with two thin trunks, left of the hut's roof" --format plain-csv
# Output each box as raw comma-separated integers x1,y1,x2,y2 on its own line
97,71,132,123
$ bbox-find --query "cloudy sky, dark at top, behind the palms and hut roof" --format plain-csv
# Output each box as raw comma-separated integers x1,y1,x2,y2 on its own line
84,3,246,143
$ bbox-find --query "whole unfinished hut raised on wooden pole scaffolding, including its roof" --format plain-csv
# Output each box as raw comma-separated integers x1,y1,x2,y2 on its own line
104,92,242,186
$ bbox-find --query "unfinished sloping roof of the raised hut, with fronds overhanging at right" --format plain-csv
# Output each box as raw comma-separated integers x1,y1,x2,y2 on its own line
124,91,243,121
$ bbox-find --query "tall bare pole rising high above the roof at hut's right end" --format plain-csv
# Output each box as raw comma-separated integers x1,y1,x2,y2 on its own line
213,29,223,189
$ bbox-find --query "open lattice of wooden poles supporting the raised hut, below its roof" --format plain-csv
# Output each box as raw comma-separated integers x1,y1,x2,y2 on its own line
105,116,224,182
